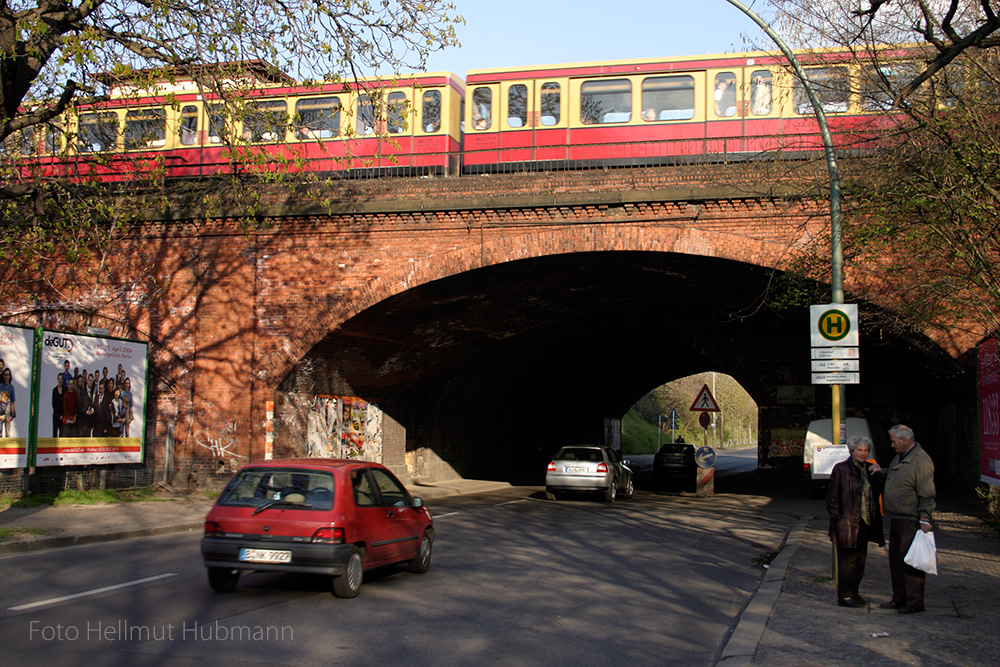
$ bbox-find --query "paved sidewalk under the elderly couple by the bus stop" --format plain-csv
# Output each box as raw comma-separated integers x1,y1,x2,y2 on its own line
732,500,1000,667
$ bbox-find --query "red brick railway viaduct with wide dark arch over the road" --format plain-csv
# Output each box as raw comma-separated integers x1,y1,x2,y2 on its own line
5,163,975,496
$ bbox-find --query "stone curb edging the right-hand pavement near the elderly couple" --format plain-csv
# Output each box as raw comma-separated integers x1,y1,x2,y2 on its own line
715,516,813,667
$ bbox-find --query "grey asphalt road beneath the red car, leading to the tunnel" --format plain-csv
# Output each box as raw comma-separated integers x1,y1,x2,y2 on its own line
0,470,793,667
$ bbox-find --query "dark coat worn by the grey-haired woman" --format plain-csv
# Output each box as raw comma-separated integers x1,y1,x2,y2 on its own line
826,459,885,549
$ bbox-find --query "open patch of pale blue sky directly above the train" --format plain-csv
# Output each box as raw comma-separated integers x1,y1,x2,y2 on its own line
427,0,771,74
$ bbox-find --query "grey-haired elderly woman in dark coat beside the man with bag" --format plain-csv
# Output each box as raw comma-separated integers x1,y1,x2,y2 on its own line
826,436,885,607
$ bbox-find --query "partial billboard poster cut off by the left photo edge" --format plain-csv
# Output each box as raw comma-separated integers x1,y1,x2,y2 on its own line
0,326,35,468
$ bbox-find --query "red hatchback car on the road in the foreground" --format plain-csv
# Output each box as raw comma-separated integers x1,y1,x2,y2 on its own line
201,459,434,598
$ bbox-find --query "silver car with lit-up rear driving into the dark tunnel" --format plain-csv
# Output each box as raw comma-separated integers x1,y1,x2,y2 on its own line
545,445,633,503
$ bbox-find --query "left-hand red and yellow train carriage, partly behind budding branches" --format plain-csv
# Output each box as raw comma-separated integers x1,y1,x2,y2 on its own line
10,64,464,182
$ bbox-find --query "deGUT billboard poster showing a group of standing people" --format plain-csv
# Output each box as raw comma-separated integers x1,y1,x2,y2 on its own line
35,330,147,466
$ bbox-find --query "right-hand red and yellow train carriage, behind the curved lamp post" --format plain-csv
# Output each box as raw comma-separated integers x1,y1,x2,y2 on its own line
463,51,916,173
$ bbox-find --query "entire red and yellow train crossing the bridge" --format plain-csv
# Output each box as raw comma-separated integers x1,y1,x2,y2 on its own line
7,46,912,181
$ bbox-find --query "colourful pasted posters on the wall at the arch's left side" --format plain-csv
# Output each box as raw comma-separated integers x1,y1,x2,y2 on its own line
307,395,382,463
